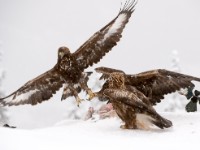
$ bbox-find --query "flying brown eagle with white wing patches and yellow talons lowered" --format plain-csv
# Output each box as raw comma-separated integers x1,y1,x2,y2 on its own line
0,0,137,106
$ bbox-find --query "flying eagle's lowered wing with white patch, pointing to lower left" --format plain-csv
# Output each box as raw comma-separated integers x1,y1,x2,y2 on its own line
0,68,64,106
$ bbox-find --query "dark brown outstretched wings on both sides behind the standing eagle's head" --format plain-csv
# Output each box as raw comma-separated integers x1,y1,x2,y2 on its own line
95,67,200,105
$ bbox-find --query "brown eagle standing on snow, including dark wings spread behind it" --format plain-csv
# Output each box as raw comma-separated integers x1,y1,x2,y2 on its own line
92,67,200,128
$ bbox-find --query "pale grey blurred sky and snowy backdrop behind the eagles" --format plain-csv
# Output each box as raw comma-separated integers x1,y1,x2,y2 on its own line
0,0,200,128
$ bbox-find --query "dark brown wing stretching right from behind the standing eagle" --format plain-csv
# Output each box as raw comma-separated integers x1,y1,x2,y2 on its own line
126,69,200,105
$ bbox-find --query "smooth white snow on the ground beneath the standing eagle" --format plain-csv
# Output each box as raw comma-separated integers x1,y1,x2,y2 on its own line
0,113,200,150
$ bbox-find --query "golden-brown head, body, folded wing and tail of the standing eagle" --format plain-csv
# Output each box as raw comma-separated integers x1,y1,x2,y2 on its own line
103,72,172,129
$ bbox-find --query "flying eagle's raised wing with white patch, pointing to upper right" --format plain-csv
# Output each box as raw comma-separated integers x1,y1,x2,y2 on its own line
73,0,137,70
